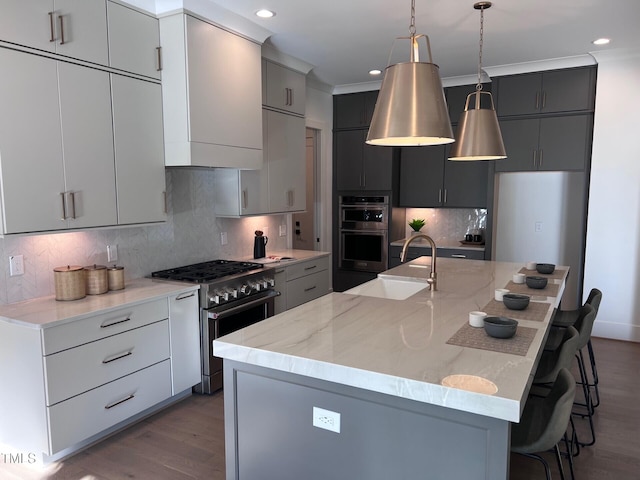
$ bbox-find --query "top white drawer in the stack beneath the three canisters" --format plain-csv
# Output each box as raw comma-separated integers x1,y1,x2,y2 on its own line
42,298,169,355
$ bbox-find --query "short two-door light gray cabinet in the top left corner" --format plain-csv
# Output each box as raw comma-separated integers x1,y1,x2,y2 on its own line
0,0,109,65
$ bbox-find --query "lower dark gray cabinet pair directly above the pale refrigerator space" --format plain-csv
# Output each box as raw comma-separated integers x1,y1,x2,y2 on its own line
496,114,593,172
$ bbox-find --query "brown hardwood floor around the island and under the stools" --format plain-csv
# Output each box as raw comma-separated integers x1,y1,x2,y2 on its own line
0,338,640,480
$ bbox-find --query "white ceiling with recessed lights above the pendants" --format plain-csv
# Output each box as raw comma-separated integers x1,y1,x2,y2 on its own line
200,0,640,86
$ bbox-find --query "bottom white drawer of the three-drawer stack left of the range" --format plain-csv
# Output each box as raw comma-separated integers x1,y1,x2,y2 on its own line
47,360,171,455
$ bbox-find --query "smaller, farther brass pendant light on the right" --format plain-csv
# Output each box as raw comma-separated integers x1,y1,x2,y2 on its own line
449,2,507,161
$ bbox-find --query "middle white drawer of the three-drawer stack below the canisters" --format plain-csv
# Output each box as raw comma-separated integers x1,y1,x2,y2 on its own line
44,320,169,405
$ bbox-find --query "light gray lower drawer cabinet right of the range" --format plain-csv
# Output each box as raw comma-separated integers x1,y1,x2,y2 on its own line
275,256,329,314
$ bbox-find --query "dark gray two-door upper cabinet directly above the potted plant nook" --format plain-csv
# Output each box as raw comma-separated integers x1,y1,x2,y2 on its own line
399,146,489,208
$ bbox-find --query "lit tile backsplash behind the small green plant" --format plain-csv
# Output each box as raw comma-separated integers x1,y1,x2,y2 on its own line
405,208,487,246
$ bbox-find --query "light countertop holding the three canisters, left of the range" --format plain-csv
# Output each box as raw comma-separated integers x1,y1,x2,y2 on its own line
0,278,200,328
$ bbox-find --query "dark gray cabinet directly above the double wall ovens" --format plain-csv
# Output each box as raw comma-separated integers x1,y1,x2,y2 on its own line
334,130,393,190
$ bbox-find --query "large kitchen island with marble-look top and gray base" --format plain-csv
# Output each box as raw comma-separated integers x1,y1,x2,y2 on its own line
214,257,568,480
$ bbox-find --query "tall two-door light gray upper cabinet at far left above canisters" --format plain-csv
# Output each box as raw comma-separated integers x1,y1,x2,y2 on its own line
0,49,116,233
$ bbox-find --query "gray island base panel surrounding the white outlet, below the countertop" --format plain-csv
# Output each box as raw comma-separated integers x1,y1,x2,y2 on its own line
224,360,510,480
